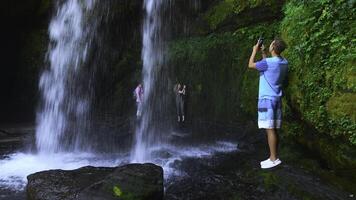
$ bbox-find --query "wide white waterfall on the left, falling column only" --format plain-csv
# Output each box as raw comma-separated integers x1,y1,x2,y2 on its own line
36,0,95,153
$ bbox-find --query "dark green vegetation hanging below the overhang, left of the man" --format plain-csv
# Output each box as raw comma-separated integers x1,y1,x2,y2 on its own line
170,23,278,121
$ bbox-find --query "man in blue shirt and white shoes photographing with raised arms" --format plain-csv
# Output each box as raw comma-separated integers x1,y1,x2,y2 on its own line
248,38,288,169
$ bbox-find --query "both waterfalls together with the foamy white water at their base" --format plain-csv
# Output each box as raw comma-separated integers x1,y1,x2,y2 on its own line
0,0,236,195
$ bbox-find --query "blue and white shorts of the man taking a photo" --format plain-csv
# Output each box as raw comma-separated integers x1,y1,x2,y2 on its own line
258,98,282,129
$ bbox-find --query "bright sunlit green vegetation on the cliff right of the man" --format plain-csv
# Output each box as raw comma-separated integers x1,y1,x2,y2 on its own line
281,0,356,144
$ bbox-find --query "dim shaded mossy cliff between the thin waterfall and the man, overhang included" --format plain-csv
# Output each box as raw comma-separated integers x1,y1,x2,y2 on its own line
170,0,284,122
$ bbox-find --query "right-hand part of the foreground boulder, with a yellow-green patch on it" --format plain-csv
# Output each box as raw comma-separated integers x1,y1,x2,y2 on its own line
78,164,163,200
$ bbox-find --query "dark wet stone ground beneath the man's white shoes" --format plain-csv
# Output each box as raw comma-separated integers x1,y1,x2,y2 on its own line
166,133,352,200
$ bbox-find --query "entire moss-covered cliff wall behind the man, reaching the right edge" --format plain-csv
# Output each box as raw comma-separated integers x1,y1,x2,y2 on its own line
170,0,356,172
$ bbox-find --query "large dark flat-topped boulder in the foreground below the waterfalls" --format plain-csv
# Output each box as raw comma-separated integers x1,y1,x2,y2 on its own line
27,164,163,200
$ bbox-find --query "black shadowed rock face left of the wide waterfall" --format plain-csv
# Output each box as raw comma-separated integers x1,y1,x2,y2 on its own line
0,0,54,122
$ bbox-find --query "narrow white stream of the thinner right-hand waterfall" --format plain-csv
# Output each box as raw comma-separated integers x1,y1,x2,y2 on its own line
131,0,169,162
